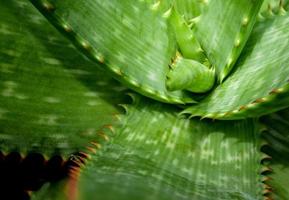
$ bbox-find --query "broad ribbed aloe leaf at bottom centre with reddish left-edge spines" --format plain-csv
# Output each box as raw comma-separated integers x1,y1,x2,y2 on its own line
55,96,262,200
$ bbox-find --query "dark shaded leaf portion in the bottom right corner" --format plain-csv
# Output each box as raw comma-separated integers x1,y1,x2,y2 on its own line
262,109,289,200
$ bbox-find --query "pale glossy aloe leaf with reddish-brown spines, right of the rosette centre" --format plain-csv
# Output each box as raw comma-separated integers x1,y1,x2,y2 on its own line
184,14,289,119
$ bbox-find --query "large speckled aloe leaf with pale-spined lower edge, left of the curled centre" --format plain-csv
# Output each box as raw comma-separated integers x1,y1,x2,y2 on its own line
31,0,198,103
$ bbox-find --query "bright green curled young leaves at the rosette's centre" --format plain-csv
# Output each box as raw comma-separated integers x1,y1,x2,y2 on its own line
165,8,215,93
